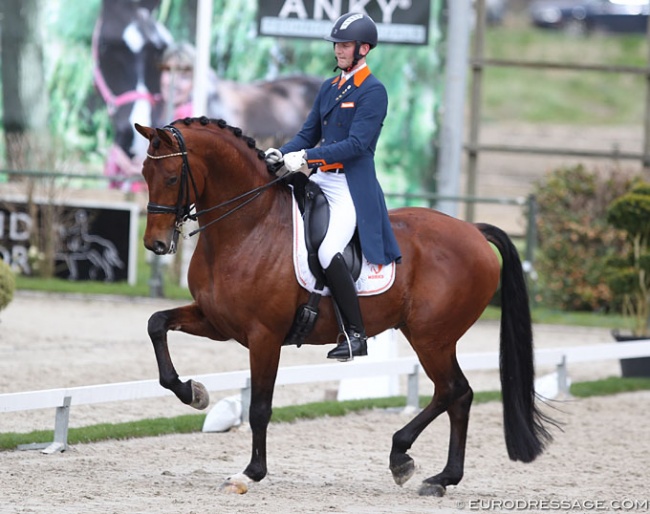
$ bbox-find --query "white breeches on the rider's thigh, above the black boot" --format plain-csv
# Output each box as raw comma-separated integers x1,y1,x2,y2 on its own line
309,171,357,269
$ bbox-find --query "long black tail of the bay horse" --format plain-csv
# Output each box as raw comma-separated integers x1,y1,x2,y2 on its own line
476,223,555,462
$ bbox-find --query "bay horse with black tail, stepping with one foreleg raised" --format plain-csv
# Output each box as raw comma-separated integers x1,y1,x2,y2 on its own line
136,118,553,496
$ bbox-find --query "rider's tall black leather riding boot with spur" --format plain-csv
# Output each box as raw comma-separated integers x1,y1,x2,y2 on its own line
324,253,368,360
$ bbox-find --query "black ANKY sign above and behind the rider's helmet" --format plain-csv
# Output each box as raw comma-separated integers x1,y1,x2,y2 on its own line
257,0,430,45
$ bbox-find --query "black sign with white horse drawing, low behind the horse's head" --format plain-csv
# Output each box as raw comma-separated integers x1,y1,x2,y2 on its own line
0,201,138,284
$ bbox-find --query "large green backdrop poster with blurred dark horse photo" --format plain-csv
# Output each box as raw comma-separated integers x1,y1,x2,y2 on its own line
0,0,443,195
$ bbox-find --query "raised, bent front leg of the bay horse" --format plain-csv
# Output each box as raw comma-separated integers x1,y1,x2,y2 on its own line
147,304,220,409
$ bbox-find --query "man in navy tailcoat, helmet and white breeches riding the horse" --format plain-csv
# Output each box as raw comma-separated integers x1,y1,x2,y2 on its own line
266,13,401,360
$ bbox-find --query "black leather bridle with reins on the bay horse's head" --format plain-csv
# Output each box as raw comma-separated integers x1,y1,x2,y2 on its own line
147,125,282,239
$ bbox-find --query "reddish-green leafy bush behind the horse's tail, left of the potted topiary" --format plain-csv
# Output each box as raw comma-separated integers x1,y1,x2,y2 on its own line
534,165,635,311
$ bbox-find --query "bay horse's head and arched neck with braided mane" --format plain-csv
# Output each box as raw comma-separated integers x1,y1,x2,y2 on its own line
135,118,272,255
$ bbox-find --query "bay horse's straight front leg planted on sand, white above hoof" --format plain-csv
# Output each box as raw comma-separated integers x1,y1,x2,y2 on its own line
222,335,282,494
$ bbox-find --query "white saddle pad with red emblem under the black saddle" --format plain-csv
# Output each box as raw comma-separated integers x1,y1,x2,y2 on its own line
292,196,395,296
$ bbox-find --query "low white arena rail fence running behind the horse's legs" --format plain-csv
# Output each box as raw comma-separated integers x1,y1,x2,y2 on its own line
0,339,650,453
